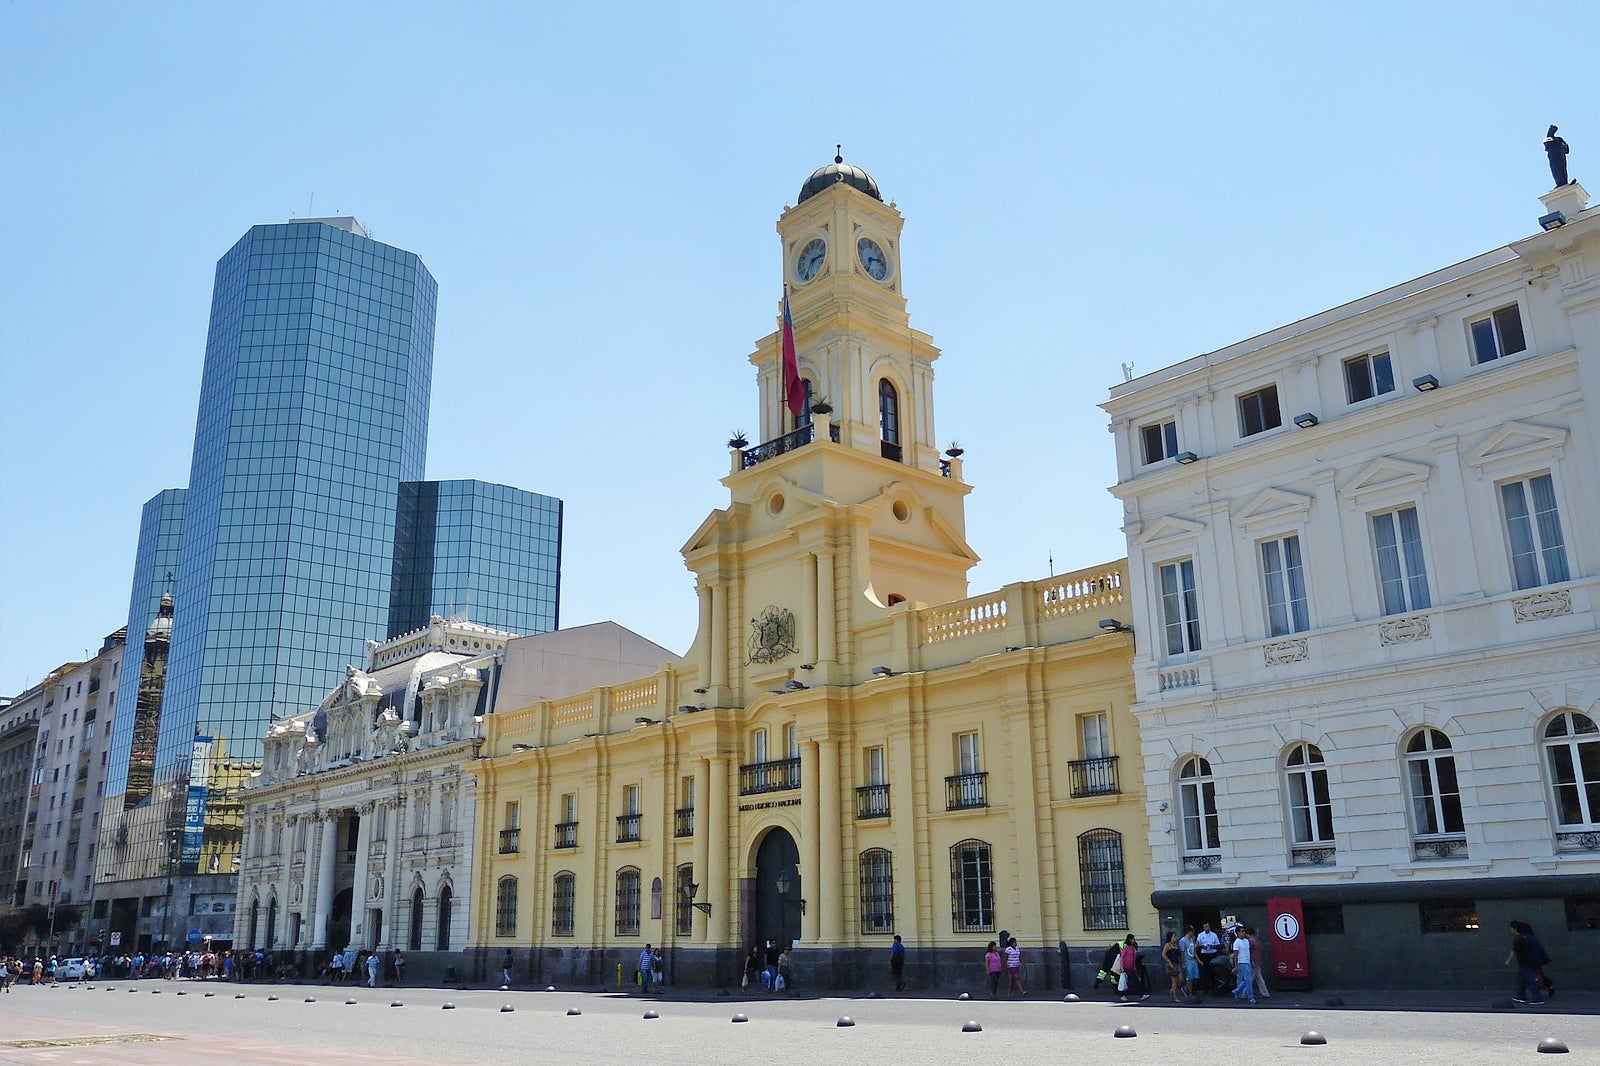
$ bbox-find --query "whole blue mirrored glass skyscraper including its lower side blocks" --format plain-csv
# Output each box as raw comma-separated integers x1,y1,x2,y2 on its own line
101,218,562,915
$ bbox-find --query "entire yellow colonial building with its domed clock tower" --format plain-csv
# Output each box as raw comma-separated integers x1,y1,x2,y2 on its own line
467,158,1155,988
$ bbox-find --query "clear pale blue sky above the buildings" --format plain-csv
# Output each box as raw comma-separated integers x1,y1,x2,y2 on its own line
0,0,1600,693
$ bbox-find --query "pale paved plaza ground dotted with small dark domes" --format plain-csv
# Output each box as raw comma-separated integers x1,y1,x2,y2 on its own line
0,981,1600,1066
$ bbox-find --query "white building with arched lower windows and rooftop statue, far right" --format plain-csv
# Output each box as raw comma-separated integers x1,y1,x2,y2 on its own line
1104,182,1600,988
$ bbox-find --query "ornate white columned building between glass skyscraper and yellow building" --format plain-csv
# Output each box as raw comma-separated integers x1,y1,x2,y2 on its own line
234,616,677,980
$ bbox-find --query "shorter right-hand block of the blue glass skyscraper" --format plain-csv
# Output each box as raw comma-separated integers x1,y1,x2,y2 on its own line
389,480,562,637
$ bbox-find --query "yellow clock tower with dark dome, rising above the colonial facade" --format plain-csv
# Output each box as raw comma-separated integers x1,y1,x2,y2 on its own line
683,155,978,706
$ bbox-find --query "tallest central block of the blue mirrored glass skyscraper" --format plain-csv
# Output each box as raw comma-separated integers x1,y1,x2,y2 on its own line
155,219,437,781
